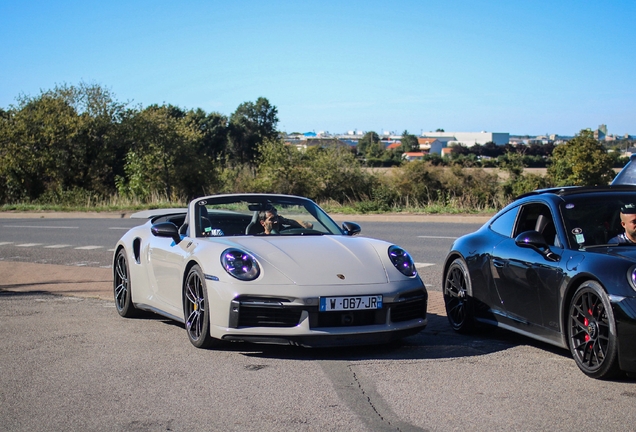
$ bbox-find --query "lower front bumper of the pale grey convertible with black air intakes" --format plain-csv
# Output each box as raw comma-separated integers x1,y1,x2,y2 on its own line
210,285,428,347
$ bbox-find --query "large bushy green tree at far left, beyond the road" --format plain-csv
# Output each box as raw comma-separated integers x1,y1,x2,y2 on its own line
0,83,127,201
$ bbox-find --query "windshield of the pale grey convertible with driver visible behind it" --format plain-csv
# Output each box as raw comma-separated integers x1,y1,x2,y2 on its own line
194,195,342,237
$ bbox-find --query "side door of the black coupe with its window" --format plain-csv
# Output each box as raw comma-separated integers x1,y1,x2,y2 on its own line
491,203,563,333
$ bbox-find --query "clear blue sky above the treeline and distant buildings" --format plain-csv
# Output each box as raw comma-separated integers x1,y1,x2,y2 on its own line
0,0,636,136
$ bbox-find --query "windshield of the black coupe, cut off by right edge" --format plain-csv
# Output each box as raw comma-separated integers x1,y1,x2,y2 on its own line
560,192,636,249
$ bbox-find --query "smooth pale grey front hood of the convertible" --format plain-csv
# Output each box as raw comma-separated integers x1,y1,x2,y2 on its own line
224,235,389,286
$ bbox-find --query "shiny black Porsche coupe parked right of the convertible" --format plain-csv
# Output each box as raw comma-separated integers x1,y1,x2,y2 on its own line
443,186,636,378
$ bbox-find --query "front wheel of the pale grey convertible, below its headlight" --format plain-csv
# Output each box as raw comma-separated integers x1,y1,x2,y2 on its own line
183,265,215,348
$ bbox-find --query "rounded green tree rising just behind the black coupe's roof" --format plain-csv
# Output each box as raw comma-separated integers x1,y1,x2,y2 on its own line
548,129,615,186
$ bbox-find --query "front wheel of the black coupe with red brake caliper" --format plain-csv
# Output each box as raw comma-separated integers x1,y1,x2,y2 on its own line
568,281,619,378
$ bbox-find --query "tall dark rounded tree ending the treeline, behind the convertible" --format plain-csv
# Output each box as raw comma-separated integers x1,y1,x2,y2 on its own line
228,97,278,163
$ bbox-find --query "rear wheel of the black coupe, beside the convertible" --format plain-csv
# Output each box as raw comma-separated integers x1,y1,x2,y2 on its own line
444,258,475,333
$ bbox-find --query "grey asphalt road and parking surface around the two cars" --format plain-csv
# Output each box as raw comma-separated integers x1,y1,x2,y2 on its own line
0,219,636,431
